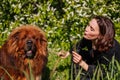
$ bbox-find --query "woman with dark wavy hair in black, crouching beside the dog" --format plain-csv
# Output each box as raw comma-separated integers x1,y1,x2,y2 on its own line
58,16,120,80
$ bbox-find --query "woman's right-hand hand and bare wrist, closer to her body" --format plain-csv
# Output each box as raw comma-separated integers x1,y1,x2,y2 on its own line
72,51,88,71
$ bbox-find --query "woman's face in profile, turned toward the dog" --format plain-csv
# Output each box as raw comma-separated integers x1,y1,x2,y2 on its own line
83,19,100,40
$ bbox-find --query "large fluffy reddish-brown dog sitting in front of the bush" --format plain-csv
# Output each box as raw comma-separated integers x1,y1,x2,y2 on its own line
0,25,48,80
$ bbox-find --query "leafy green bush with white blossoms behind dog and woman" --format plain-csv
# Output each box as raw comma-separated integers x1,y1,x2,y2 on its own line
0,0,120,80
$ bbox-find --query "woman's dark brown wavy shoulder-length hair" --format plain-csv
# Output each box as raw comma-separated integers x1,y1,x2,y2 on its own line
93,16,115,51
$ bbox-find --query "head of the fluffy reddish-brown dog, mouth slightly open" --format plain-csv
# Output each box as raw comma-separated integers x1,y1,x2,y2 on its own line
7,25,47,59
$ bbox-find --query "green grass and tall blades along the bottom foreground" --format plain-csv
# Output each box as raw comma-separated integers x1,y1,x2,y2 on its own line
0,47,120,80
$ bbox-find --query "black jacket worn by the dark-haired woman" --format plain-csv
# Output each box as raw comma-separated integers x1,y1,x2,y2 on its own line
70,38,120,79
